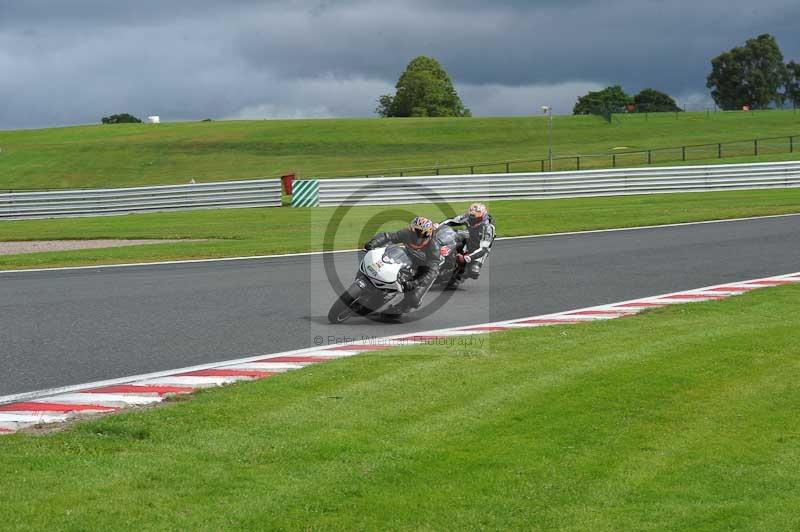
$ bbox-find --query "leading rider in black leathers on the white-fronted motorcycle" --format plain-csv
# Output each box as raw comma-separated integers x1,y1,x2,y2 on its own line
364,216,440,316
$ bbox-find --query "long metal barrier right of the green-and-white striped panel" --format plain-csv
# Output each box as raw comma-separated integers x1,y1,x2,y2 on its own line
304,162,800,207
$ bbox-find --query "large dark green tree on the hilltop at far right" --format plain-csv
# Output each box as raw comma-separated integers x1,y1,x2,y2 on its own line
706,33,786,110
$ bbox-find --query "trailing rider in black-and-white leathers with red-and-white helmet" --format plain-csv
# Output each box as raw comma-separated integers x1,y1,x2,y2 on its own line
442,203,495,288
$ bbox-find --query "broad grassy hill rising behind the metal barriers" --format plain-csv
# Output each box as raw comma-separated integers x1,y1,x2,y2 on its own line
0,111,800,190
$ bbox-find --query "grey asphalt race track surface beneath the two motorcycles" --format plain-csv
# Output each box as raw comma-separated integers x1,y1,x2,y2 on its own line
0,217,800,396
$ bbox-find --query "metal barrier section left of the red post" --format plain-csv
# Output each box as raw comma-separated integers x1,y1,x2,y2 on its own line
0,179,281,220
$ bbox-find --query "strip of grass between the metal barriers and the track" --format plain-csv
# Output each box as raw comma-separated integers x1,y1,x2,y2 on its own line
0,189,800,269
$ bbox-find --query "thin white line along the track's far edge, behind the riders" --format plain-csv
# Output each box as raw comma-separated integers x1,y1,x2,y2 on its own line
0,213,800,274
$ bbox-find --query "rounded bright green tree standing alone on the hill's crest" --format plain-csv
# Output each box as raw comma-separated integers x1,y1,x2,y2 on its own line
375,55,471,117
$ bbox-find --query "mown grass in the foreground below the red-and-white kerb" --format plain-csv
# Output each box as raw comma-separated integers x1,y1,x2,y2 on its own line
0,286,800,531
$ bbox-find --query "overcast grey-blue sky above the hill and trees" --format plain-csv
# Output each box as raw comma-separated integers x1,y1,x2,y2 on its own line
0,0,800,129
